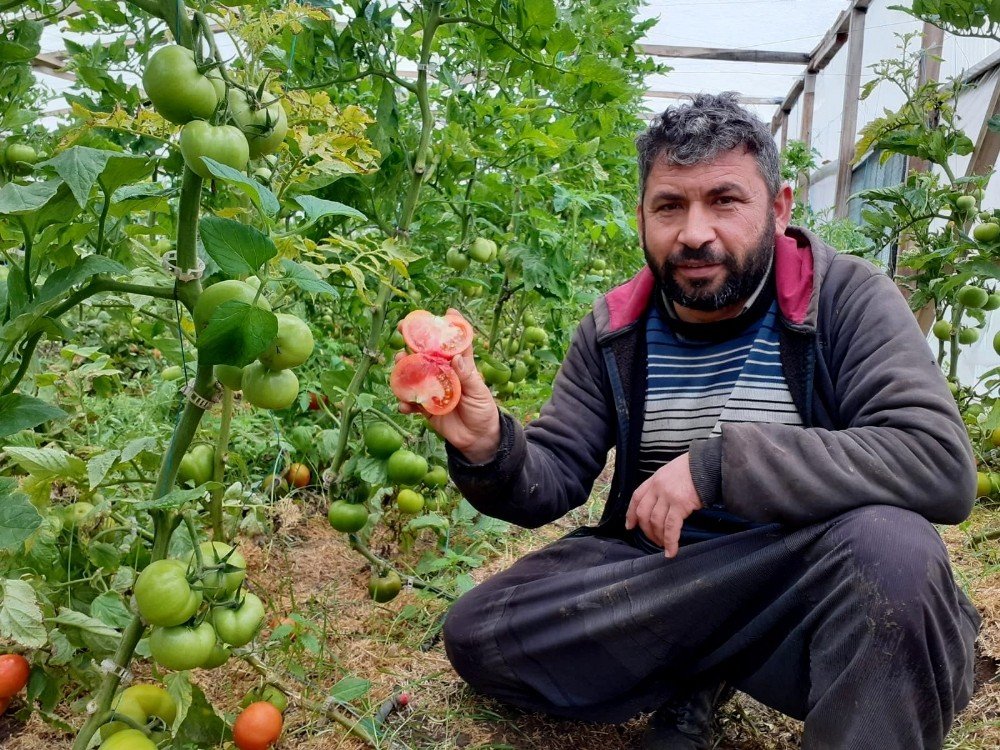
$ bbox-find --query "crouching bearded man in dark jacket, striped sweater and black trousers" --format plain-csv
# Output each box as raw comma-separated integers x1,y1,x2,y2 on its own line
402,94,979,750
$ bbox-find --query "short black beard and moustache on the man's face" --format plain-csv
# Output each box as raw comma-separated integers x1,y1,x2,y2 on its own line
642,209,775,312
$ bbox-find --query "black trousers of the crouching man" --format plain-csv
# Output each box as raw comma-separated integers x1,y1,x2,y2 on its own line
444,505,980,750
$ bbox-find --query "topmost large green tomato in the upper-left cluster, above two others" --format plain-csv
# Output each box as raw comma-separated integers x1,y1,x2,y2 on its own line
142,44,219,125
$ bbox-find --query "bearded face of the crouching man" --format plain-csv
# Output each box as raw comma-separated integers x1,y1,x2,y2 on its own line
637,149,791,322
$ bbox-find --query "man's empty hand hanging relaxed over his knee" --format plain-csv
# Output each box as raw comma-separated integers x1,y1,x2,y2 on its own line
625,453,701,557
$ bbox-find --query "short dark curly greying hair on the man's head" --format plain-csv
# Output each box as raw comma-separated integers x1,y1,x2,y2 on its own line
635,91,781,199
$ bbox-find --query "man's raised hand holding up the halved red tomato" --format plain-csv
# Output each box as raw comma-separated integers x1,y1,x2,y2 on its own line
396,308,500,464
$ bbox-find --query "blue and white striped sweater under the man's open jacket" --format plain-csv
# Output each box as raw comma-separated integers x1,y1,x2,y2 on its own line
638,283,802,546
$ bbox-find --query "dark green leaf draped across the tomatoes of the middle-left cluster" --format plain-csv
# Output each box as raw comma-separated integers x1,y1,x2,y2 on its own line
195,300,278,367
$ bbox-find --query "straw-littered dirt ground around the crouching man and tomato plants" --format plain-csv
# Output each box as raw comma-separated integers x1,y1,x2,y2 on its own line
0,494,1000,750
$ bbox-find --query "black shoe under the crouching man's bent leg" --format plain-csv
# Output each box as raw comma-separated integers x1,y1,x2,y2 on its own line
640,682,733,750
